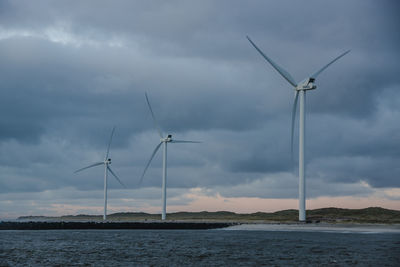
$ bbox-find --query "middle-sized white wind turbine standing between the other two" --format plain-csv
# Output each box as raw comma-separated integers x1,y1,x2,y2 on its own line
140,93,201,220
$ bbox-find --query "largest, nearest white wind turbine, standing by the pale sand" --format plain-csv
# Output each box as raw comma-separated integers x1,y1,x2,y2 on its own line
246,36,350,221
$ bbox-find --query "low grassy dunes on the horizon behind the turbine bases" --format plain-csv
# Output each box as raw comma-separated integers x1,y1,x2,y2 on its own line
12,207,400,224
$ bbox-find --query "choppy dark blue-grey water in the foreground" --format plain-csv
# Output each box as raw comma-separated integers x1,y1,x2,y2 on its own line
0,230,400,266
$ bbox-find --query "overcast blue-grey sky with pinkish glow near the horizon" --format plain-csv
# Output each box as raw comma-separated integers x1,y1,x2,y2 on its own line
0,0,400,218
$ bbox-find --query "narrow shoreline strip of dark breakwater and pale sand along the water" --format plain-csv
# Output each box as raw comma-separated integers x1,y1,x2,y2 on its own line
0,221,400,233
